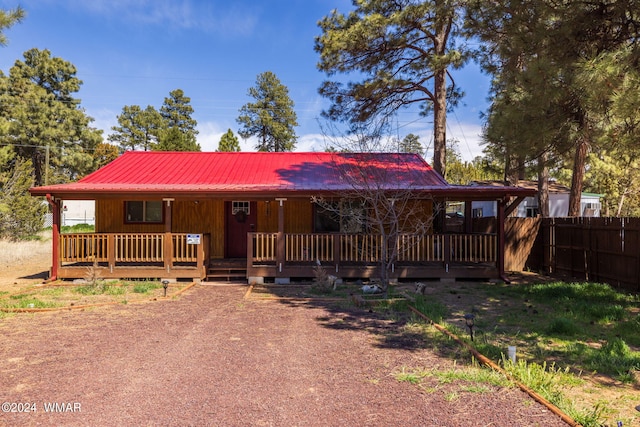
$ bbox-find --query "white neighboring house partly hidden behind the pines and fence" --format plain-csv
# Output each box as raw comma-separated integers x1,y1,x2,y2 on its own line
471,180,603,218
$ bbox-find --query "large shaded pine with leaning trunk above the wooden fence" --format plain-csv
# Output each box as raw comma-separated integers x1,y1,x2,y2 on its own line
468,0,640,216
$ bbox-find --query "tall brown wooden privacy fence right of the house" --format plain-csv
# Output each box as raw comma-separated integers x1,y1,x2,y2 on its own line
473,217,640,292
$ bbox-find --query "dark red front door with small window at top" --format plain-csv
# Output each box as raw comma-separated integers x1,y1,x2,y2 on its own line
224,201,258,258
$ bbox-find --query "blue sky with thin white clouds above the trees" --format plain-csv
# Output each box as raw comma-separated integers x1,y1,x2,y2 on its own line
0,0,489,160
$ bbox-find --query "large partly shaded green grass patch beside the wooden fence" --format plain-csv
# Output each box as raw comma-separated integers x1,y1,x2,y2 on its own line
404,282,640,426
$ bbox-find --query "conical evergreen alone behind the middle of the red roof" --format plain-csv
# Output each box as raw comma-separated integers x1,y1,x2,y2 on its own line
236,71,298,151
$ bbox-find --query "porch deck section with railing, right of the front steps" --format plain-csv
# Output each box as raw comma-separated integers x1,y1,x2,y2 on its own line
247,233,502,283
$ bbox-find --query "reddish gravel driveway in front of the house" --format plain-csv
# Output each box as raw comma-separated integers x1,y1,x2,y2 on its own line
0,285,566,427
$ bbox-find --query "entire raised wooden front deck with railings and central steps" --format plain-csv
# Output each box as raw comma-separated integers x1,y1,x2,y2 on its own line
52,233,500,281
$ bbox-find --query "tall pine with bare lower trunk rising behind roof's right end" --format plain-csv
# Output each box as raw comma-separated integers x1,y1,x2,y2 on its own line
315,0,466,175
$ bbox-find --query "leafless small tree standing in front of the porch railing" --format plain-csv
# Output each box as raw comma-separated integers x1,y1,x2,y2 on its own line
314,125,434,294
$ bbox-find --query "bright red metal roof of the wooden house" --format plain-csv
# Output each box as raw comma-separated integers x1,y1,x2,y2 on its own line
30,151,536,198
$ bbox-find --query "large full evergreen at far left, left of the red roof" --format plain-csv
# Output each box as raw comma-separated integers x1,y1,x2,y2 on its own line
0,49,102,185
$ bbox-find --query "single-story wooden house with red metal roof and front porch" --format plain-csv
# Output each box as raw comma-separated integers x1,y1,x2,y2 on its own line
30,152,534,283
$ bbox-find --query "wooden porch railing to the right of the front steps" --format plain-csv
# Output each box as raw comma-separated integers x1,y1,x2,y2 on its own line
249,233,498,263
